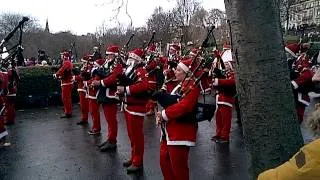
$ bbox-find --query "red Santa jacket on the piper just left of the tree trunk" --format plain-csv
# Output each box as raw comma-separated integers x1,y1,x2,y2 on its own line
212,71,236,107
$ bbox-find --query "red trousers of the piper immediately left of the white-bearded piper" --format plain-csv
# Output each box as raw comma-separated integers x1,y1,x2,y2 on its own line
102,104,118,143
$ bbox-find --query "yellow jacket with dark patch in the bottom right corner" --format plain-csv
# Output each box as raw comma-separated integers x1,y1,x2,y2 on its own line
258,139,320,180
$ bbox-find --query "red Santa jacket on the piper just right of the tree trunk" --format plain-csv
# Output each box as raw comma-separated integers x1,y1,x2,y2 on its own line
291,68,314,106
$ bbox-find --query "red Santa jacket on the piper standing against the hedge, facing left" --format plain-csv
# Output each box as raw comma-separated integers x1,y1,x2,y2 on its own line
56,60,73,86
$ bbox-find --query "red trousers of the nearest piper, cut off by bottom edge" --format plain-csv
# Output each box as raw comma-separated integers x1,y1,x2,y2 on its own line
160,141,190,180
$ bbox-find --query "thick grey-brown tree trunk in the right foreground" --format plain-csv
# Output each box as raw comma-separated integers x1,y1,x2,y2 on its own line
225,0,303,179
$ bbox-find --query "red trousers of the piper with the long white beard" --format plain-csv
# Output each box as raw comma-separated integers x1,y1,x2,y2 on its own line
124,111,144,166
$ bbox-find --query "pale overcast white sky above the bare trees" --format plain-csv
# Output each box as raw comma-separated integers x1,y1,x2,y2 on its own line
0,0,224,35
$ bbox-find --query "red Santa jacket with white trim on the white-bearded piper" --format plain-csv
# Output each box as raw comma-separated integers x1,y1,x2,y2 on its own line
124,67,150,116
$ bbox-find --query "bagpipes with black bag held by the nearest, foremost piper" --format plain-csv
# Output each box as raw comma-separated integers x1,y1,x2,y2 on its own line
152,26,216,122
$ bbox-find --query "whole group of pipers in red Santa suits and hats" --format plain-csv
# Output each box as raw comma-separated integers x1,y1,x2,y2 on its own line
0,35,320,180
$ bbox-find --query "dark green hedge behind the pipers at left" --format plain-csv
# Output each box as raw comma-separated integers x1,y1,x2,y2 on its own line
17,66,78,107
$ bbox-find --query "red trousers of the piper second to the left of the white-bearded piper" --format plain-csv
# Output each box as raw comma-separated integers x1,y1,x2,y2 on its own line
89,99,101,131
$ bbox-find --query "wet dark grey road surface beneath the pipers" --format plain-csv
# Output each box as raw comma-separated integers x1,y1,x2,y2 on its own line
0,106,247,180
